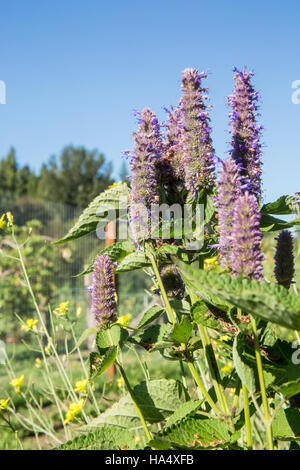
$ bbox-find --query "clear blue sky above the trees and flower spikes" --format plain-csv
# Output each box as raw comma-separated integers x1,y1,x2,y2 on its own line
0,0,300,201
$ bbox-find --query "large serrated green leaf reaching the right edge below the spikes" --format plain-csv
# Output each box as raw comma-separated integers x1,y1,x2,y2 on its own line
176,260,300,330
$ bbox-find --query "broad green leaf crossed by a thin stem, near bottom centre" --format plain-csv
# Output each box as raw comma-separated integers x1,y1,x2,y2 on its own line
87,379,188,430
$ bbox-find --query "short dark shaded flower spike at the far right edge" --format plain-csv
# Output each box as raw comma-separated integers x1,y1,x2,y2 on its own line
274,230,295,289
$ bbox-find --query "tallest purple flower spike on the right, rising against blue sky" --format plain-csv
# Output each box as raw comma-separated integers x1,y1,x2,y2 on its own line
228,68,262,198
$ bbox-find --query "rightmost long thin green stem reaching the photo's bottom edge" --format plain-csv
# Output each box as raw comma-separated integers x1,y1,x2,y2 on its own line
251,317,273,450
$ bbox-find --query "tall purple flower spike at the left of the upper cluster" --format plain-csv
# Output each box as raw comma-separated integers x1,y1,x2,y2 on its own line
130,108,162,241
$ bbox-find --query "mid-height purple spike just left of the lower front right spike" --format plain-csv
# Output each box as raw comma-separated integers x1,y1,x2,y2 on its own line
217,158,242,269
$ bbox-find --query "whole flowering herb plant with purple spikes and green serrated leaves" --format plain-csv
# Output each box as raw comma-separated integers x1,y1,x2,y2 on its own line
52,69,300,450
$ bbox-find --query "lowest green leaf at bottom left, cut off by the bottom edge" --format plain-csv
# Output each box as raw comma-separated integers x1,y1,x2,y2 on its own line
54,425,136,450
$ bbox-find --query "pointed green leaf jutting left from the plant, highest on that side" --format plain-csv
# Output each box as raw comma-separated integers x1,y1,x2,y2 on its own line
55,185,130,244
